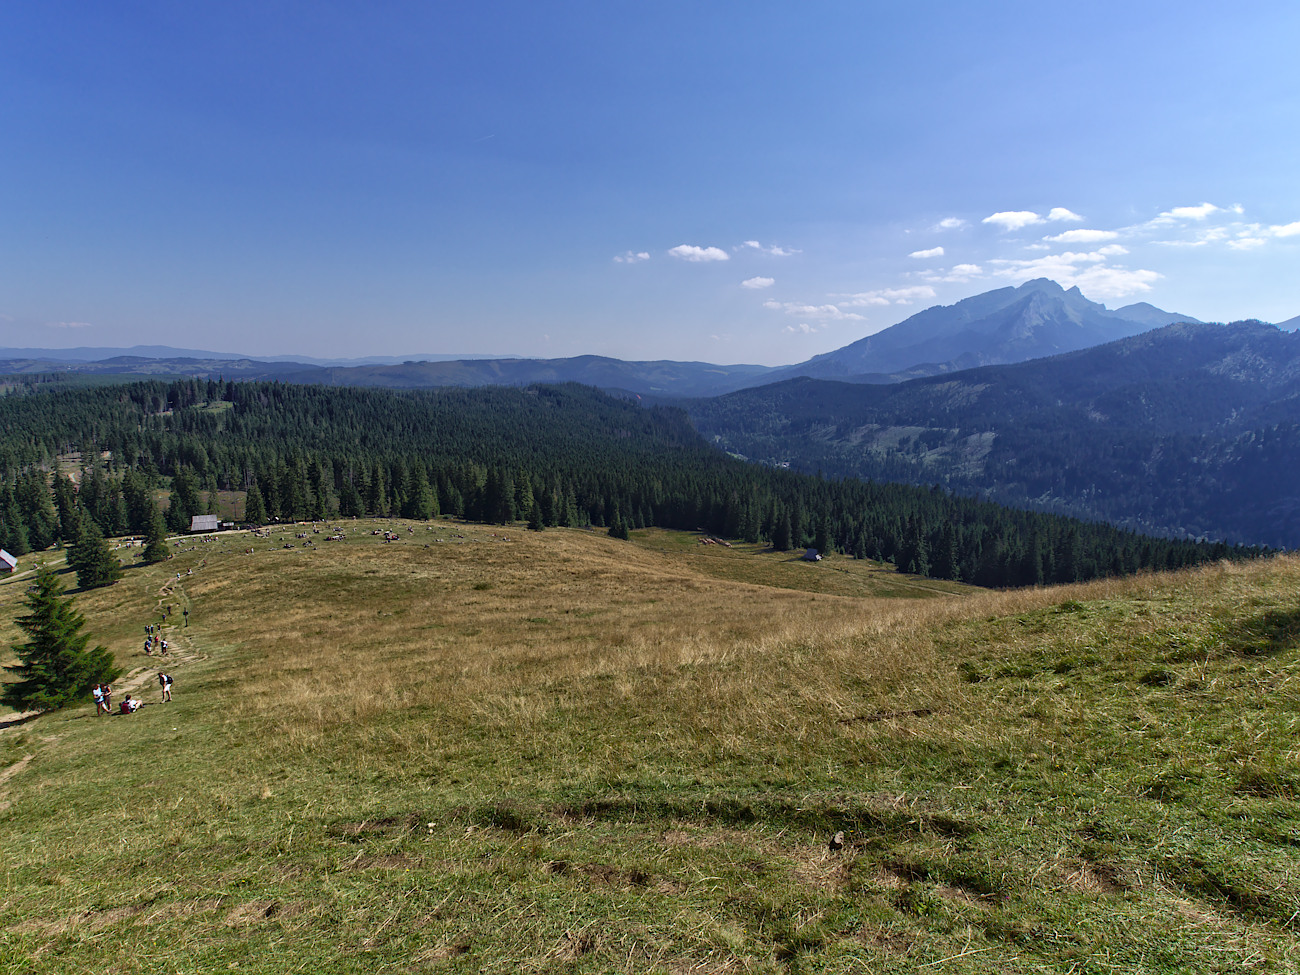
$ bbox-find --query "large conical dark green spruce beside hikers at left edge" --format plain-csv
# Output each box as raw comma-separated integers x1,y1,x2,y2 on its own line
0,568,121,711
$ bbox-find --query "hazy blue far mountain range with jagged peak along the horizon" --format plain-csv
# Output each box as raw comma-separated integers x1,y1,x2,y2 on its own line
0,278,1232,398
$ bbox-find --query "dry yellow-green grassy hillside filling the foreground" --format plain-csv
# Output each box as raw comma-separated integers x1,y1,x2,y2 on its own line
0,521,1300,974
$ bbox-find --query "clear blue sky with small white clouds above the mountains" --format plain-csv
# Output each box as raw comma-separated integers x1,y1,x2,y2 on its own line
0,0,1300,364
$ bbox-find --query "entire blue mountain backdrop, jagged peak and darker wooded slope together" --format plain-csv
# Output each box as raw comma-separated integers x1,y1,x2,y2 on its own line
10,280,1300,547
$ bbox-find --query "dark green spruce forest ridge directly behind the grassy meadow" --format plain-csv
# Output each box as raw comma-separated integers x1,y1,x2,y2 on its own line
0,380,1258,586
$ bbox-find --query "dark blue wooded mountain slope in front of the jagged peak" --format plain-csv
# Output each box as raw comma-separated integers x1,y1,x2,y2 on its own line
690,321,1300,547
